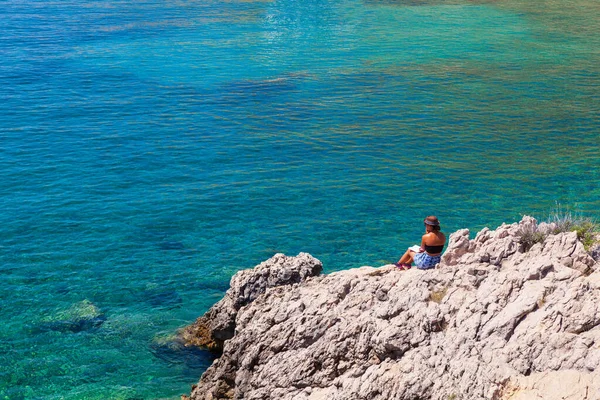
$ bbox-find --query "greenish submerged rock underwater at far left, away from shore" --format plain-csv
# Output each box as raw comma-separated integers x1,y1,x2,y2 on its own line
39,300,106,332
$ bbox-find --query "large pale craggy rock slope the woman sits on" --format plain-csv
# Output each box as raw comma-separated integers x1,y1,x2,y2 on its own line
191,217,600,400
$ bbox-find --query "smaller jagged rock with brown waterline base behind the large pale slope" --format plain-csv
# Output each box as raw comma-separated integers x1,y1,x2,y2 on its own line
178,253,323,351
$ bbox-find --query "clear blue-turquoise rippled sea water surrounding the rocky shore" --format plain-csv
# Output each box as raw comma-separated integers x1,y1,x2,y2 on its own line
0,0,600,399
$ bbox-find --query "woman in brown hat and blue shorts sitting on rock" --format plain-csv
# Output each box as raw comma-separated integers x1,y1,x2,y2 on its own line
395,215,446,270
